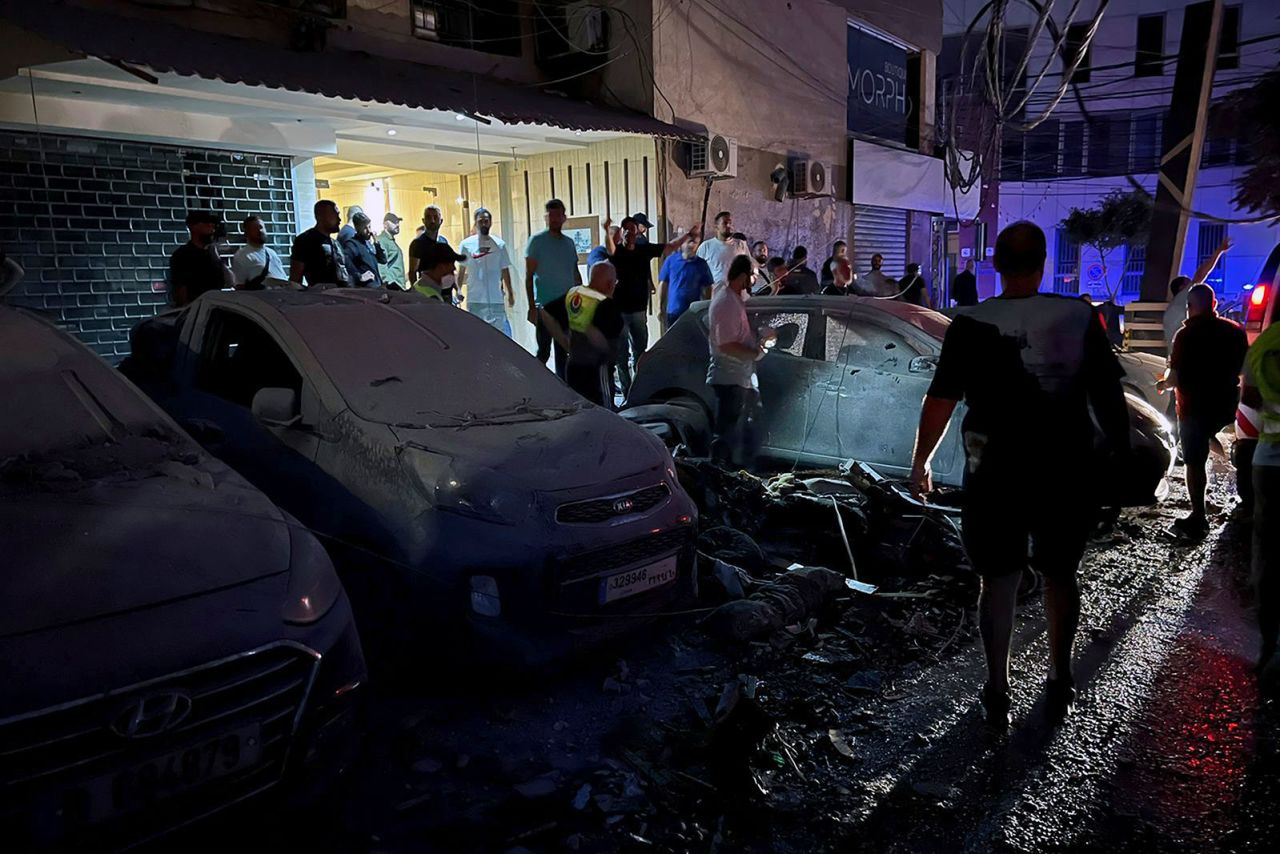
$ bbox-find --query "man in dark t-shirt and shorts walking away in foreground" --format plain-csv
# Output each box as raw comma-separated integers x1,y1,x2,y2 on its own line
911,222,1129,727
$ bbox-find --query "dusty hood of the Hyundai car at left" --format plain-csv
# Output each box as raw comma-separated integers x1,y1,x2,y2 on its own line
0,438,291,638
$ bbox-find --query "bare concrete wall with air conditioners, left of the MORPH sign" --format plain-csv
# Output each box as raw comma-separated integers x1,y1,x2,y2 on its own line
653,0,851,262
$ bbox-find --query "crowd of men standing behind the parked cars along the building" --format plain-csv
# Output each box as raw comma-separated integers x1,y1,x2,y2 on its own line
169,198,952,406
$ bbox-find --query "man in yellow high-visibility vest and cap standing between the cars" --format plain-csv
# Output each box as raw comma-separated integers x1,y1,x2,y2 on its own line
543,261,623,408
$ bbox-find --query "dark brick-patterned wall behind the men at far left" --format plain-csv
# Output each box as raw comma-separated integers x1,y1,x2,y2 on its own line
0,131,296,361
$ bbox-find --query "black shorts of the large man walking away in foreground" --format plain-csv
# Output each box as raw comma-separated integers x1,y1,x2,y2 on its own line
961,472,1097,579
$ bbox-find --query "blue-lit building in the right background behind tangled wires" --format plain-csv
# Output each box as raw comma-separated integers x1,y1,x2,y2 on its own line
943,0,1280,305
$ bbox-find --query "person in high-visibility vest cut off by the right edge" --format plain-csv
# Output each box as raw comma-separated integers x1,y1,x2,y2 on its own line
1242,317,1280,670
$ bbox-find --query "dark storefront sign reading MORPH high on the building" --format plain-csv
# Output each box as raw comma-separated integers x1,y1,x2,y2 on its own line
849,26,915,143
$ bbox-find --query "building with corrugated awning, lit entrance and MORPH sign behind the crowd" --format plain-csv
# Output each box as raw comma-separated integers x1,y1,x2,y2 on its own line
0,0,952,359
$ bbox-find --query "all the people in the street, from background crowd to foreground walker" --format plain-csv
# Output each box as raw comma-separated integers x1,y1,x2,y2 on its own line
137,198,1280,726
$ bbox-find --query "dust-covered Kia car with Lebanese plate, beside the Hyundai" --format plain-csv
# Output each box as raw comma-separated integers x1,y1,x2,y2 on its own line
123,288,696,659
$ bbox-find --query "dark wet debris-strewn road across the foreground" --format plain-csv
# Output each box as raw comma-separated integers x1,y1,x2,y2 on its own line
201,463,1280,851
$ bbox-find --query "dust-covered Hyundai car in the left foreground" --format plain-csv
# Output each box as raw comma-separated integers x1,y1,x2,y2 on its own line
0,307,366,850
